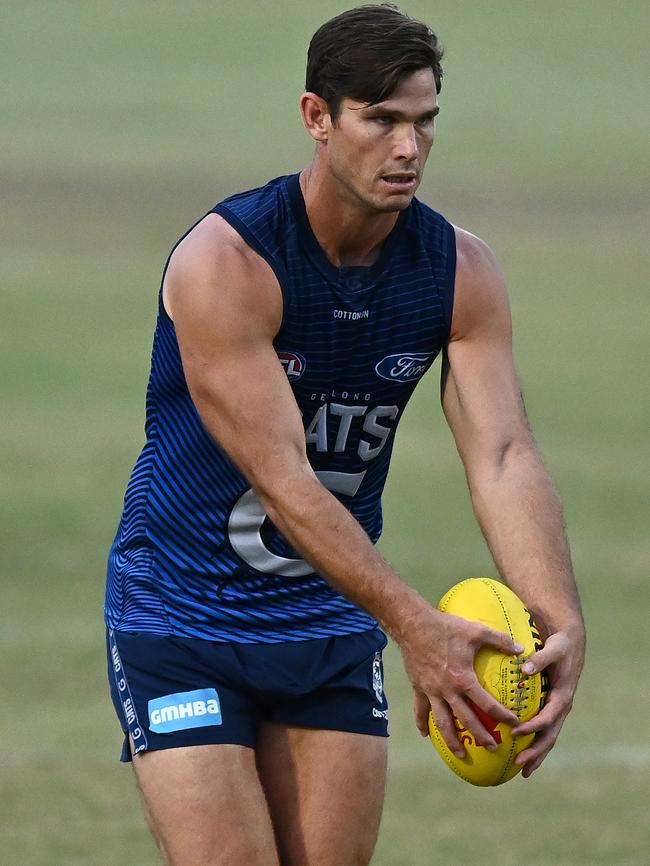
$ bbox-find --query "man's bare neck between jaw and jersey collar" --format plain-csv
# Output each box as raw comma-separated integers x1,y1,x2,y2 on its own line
300,161,399,267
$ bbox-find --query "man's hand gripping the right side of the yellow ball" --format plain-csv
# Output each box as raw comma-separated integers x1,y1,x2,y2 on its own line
512,631,584,778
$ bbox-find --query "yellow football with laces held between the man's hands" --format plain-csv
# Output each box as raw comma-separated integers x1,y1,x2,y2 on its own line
429,577,548,786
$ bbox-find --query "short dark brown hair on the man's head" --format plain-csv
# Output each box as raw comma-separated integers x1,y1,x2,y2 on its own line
305,3,443,120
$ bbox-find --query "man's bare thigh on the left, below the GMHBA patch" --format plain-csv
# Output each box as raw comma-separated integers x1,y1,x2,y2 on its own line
133,744,279,866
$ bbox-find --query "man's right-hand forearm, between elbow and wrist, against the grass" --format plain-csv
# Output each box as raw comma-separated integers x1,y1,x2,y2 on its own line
468,440,583,634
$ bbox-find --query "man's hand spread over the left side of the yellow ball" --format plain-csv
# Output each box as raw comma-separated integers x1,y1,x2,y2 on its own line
399,607,523,758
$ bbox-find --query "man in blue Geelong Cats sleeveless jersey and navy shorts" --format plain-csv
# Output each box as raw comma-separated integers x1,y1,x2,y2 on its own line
106,6,584,866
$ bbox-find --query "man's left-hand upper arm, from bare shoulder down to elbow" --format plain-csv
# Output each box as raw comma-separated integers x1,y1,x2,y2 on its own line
168,218,306,488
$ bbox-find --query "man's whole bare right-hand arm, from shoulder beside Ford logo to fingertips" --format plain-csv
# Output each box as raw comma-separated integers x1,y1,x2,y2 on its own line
442,230,584,775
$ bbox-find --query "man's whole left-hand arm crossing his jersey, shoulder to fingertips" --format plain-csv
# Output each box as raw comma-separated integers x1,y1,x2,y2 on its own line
165,215,516,754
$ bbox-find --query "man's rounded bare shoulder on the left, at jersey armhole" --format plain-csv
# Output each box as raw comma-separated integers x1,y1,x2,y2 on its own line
163,213,282,330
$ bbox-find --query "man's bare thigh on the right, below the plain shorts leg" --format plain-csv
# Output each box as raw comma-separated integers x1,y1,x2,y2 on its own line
257,722,387,866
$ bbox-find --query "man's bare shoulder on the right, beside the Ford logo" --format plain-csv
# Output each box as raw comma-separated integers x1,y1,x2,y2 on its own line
450,226,510,340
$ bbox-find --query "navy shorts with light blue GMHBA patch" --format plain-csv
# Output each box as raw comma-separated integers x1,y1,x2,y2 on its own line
107,629,388,761
